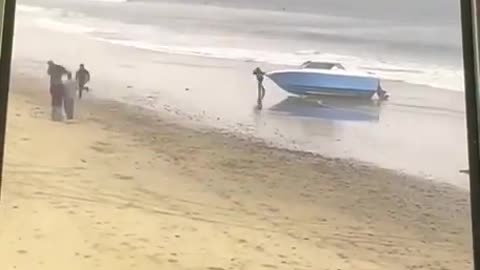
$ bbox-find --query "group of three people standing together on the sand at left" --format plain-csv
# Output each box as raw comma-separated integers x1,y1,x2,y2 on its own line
47,61,90,121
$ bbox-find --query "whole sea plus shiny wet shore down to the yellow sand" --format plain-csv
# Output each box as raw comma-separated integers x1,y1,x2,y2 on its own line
14,0,468,187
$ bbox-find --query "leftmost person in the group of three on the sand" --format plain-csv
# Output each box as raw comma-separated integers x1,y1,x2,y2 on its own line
47,60,68,121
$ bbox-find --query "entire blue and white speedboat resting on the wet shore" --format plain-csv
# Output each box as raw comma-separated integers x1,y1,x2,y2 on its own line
266,61,386,99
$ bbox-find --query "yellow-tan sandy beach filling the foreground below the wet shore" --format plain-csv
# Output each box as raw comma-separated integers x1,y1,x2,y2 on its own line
0,74,471,270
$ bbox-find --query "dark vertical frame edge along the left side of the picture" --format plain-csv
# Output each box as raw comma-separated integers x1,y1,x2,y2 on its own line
0,0,16,198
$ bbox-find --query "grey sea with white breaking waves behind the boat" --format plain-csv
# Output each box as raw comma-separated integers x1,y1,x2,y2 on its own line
17,0,463,91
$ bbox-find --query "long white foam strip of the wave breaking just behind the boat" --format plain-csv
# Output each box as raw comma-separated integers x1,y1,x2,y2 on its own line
94,38,463,91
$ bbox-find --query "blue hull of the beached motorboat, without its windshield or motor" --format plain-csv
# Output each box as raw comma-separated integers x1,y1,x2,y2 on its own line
267,71,379,99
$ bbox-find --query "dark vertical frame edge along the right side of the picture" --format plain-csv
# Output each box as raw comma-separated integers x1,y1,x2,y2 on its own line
460,0,480,270
